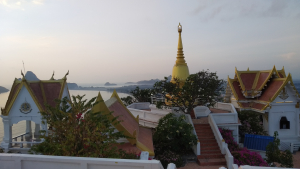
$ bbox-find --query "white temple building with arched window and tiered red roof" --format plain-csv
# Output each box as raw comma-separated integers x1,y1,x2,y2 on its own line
224,66,300,149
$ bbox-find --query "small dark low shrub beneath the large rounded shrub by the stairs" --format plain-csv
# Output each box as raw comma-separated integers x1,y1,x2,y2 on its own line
156,150,183,168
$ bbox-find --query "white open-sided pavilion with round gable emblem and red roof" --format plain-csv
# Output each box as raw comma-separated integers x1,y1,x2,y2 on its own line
1,72,70,151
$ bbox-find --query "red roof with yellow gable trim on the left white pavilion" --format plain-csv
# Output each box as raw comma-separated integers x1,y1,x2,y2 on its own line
1,73,68,116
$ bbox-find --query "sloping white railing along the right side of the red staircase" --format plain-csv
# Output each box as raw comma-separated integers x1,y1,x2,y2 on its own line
208,114,233,169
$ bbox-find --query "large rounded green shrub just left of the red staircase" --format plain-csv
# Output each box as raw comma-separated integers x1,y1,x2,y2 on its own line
153,113,197,154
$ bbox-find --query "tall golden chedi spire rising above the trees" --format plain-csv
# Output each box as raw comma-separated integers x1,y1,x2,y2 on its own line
171,23,190,82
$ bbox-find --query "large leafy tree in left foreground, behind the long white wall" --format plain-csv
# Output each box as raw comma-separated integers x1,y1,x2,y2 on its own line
31,96,129,158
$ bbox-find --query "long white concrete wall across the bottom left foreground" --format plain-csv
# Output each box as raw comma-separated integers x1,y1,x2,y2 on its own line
0,153,163,169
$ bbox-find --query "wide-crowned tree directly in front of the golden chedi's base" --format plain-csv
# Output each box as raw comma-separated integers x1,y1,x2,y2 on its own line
154,70,224,113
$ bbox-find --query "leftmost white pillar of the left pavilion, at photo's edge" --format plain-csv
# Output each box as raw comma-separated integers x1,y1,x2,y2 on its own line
1,116,12,152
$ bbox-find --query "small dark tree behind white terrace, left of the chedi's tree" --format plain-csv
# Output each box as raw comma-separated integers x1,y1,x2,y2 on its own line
121,86,154,106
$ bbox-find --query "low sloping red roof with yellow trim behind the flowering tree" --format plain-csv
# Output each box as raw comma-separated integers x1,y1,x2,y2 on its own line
92,91,154,156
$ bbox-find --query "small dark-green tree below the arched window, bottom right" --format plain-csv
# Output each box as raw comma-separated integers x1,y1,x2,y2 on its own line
266,131,293,168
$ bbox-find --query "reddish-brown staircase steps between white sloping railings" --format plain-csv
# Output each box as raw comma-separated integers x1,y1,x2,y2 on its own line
194,124,226,167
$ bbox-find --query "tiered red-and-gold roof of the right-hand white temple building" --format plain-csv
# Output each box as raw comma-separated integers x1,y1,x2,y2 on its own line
228,66,300,111
